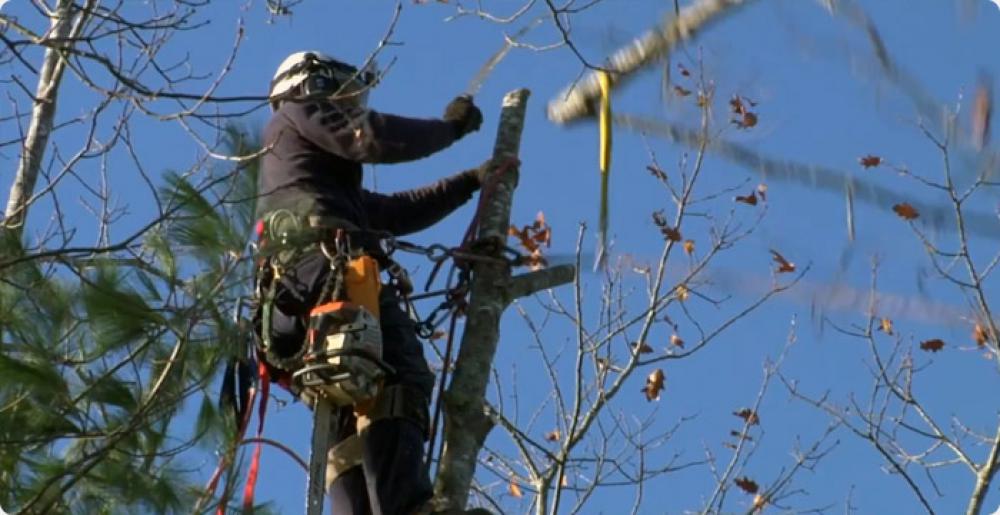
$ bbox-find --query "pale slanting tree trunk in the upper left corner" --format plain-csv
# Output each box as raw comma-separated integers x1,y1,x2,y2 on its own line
2,0,86,238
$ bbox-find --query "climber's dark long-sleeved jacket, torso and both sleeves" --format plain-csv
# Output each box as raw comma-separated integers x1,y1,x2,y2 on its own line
257,101,479,235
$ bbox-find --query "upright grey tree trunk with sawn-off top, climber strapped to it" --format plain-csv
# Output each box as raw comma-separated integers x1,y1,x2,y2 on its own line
433,89,574,510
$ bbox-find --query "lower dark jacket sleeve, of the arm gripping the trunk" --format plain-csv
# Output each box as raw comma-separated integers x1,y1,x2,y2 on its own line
362,170,479,236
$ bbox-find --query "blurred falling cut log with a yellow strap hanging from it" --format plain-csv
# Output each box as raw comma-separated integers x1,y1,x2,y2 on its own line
548,0,751,124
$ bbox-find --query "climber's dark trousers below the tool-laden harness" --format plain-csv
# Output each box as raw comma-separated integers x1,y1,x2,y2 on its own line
271,252,434,515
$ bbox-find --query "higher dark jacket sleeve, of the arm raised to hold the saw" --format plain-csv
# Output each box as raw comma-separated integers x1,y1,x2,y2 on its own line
282,102,456,163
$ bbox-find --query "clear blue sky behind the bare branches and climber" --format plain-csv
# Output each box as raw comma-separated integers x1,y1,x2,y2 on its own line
8,0,1000,513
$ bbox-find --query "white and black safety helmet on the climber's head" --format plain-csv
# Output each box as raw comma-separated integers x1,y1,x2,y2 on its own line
268,51,377,109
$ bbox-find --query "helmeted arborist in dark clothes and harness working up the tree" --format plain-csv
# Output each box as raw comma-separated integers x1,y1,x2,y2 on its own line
255,52,487,514
